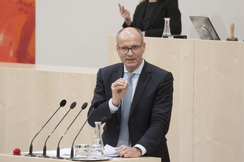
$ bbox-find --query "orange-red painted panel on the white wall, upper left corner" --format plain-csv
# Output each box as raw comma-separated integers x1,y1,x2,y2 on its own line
0,0,35,64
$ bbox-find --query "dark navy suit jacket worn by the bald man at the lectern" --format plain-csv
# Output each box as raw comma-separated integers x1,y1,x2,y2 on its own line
88,61,173,162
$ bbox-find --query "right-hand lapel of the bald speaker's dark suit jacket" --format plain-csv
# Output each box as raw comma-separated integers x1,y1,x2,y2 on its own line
130,61,151,116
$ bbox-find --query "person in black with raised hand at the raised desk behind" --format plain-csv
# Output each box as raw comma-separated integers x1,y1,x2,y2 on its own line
118,0,181,37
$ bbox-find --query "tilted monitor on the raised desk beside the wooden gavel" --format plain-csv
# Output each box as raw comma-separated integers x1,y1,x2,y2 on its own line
190,16,220,40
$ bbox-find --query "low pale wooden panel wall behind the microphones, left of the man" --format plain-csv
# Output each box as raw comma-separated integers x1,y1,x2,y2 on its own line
0,63,97,153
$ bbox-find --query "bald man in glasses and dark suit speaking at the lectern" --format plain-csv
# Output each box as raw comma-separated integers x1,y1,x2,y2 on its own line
88,27,173,162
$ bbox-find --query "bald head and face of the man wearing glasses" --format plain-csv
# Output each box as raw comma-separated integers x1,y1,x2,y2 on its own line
117,28,146,72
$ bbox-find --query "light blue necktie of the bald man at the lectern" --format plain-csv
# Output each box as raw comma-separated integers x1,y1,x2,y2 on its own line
117,73,135,146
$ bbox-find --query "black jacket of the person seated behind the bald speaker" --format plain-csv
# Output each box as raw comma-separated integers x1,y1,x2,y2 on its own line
123,0,181,37
